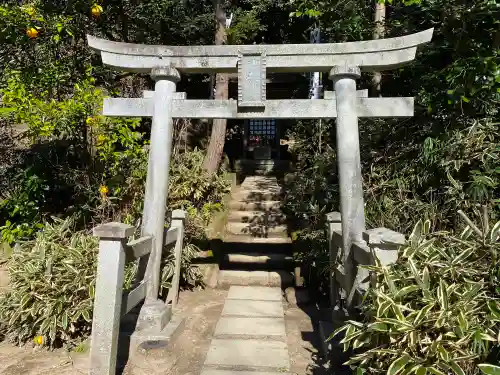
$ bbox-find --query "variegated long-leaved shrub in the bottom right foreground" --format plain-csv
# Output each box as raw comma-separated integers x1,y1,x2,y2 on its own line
333,210,500,375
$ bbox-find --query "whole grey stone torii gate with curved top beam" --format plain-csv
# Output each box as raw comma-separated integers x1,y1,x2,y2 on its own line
87,29,433,328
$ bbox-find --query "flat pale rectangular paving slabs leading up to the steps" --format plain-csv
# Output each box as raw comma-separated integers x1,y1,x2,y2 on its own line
201,286,290,375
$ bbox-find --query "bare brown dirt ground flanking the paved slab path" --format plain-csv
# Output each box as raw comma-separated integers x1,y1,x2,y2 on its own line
0,289,328,375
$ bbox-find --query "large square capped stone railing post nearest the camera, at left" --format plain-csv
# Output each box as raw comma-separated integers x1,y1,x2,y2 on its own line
89,223,134,375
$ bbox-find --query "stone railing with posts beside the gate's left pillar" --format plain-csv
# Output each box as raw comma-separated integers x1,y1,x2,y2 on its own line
89,210,186,375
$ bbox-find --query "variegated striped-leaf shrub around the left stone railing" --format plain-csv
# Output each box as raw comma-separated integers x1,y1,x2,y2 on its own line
0,214,207,347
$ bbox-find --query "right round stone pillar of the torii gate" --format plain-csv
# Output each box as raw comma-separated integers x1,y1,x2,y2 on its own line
330,66,365,300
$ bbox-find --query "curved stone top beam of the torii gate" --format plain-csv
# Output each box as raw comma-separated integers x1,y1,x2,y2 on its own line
87,28,433,73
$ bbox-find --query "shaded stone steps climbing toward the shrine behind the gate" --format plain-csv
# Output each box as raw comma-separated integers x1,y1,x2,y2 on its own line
218,176,293,287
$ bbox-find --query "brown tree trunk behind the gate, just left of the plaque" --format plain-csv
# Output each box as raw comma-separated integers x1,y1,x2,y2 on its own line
203,0,229,175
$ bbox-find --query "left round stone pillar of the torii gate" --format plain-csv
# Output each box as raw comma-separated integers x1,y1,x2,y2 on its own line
139,66,180,330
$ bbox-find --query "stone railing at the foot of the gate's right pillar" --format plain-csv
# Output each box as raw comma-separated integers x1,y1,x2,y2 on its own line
327,212,405,309
